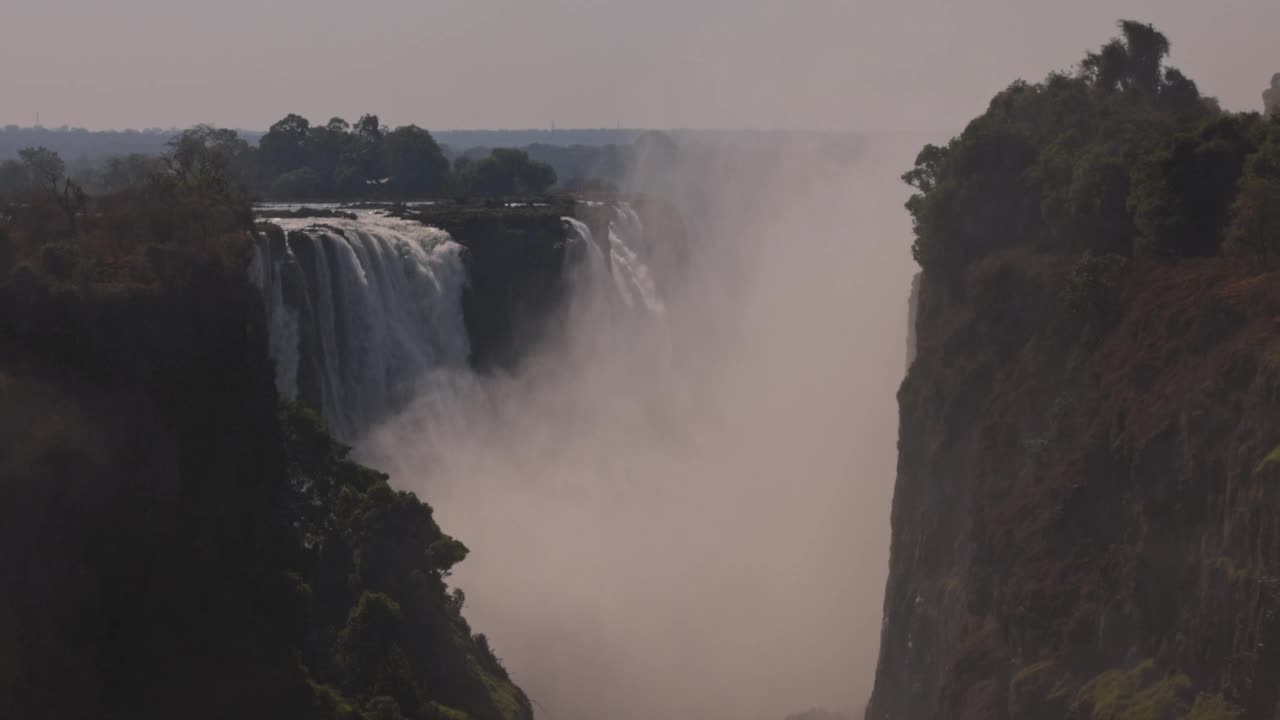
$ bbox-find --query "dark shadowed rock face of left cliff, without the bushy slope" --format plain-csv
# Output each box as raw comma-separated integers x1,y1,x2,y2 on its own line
0,242,307,717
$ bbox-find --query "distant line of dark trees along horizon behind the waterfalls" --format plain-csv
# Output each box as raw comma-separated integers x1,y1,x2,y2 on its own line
0,114,691,200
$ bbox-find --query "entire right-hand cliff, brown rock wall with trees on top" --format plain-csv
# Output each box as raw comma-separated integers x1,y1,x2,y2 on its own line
867,20,1280,720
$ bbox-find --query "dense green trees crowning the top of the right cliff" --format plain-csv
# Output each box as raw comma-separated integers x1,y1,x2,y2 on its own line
902,20,1280,273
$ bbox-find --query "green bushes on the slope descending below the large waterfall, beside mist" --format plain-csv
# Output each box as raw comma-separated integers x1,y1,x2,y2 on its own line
280,404,529,720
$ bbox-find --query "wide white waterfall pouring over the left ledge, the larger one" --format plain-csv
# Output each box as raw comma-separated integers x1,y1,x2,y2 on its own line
251,213,470,441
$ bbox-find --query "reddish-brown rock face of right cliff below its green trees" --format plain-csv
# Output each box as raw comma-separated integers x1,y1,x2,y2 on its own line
867,250,1280,720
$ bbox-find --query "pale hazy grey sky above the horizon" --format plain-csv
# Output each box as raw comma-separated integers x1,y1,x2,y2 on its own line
0,0,1280,129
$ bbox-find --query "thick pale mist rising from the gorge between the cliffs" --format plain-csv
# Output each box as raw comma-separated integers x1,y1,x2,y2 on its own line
358,135,911,720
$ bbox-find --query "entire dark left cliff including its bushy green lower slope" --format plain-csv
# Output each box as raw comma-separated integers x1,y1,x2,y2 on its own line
0,237,532,720
